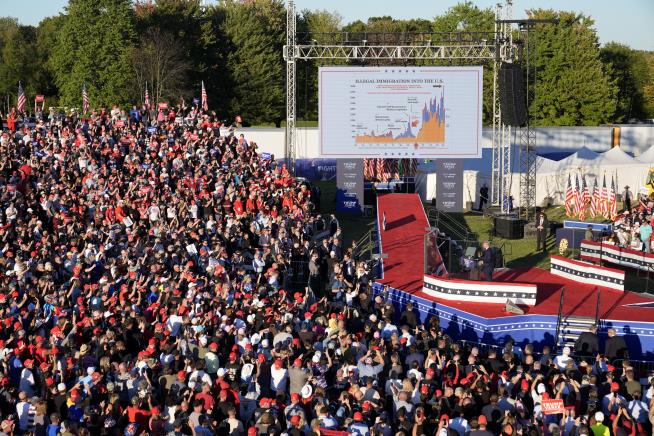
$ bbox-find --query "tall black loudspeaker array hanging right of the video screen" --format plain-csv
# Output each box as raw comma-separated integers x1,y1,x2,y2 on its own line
499,63,527,127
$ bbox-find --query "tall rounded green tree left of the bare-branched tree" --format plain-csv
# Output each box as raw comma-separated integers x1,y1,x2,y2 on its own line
51,0,136,107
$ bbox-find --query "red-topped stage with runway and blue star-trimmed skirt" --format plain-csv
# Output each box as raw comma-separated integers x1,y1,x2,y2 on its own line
375,194,654,359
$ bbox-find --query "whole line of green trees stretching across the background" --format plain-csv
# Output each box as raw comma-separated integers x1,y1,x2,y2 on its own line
0,0,654,126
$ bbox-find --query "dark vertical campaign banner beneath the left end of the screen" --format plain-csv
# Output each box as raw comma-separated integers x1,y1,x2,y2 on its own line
336,159,363,213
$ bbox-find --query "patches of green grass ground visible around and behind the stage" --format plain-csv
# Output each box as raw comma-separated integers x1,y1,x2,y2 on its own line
317,181,654,293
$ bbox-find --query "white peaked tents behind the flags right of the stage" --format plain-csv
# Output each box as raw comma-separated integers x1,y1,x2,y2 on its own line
511,147,654,206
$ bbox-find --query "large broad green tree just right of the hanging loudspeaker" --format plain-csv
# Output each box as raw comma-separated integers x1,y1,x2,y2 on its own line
528,9,617,126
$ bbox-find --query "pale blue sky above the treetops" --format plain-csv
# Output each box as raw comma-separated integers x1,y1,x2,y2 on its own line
0,0,654,50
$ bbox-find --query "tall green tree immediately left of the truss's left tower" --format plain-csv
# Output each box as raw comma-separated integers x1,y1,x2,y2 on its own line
222,0,286,125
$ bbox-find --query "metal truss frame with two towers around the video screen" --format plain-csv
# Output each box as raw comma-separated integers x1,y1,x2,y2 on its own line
284,0,517,212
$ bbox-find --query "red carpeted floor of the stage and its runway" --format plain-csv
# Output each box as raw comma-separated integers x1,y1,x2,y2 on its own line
377,194,654,352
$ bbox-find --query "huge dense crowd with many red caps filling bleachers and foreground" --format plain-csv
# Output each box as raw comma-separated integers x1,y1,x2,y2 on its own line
0,107,654,436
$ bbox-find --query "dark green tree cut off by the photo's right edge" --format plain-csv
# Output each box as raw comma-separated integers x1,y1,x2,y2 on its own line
600,42,652,123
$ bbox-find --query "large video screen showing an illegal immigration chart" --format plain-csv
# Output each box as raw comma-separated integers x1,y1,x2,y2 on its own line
318,66,483,159
